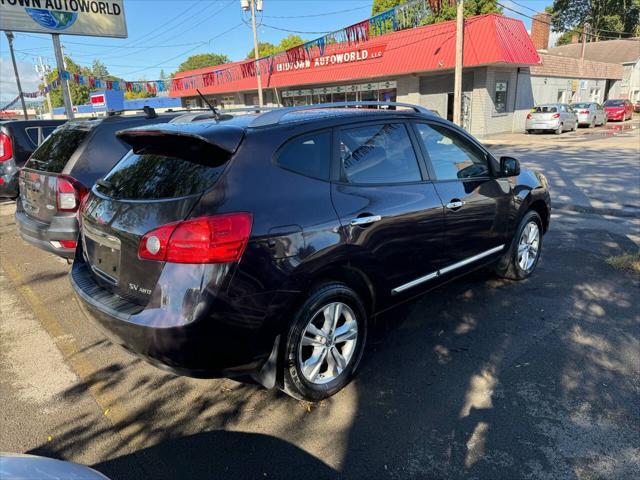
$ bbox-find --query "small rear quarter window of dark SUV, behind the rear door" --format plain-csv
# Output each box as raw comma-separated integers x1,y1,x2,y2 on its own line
276,131,331,180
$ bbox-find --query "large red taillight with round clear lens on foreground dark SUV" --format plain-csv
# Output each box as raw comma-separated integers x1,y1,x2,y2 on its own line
138,213,253,263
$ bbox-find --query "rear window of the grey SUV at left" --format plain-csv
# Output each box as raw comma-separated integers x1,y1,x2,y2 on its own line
25,126,93,173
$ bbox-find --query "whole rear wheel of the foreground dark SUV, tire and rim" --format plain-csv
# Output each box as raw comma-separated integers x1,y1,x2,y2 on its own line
283,282,367,402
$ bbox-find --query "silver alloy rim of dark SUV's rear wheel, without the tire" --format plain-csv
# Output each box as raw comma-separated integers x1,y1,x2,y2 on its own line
298,302,358,385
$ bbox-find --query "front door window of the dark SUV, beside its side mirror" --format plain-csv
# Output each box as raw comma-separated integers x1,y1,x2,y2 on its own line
416,123,489,180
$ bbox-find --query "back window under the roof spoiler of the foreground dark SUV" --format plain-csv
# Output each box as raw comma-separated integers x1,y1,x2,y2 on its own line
96,150,226,200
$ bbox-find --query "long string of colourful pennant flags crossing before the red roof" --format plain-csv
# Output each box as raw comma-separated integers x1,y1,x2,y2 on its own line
17,0,455,98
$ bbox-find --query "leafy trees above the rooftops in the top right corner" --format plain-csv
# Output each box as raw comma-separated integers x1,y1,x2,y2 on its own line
551,0,640,41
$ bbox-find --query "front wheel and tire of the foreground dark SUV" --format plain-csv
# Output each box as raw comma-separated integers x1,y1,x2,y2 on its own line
496,210,542,280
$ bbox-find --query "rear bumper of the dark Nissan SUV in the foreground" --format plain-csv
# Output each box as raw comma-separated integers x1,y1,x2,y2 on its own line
70,256,286,378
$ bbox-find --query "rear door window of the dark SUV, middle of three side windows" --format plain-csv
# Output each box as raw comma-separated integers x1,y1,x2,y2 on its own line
340,123,422,184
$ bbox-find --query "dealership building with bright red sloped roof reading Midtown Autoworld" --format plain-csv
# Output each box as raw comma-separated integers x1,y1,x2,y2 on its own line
170,14,636,136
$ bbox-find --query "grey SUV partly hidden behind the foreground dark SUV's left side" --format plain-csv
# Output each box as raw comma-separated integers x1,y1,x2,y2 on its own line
16,112,177,259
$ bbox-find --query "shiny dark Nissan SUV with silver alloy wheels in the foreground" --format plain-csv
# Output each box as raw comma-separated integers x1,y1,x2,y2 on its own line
70,102,550,400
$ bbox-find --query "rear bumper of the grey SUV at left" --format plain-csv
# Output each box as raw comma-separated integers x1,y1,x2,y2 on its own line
16,199,78,259
